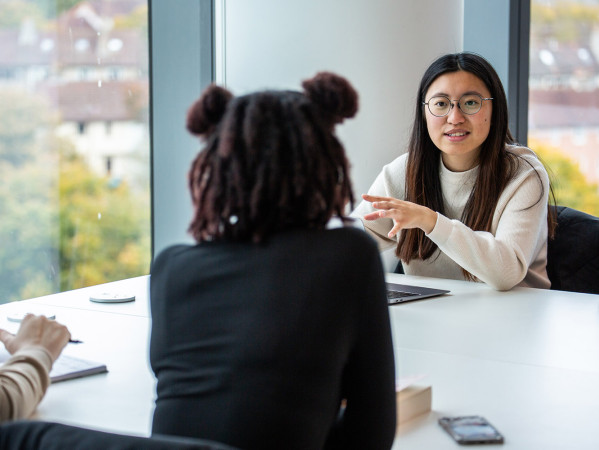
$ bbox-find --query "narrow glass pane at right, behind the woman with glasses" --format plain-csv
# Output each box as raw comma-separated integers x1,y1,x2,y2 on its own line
528,0,599,216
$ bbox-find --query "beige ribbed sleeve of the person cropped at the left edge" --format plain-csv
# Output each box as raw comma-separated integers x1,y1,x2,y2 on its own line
0,347,52,421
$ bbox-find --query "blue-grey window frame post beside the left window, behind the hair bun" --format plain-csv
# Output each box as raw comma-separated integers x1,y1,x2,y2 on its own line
148,0,215,260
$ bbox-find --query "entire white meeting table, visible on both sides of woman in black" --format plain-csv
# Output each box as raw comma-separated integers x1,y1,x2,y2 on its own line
0,274,599,450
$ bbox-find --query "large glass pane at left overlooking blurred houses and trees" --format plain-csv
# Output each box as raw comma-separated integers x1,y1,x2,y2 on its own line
0,0,150,303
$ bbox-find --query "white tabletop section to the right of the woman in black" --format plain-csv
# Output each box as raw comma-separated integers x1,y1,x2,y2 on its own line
387,274,599,450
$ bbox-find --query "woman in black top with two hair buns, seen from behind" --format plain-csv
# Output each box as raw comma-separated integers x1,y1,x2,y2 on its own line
150,72,396,450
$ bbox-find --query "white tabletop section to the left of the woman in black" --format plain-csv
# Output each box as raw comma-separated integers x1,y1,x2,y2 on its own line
0,276,155,436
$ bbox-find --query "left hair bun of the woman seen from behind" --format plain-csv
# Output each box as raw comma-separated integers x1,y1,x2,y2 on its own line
187,84,233,136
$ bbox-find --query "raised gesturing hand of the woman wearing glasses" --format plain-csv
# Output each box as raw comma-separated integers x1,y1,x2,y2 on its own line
362,194,437,238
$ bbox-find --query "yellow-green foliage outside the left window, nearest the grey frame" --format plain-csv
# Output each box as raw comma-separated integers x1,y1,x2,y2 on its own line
58,146,150,290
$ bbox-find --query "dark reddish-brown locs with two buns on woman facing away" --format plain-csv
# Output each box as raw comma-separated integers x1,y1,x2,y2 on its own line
187,72,358,242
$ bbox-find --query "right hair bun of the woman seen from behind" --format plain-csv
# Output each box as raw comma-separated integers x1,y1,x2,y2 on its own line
302,72,358,124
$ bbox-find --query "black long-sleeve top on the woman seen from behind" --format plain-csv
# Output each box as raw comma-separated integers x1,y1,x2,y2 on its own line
150,228,396,450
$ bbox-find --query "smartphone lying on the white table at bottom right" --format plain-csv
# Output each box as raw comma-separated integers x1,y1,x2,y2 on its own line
439,416,503,445
